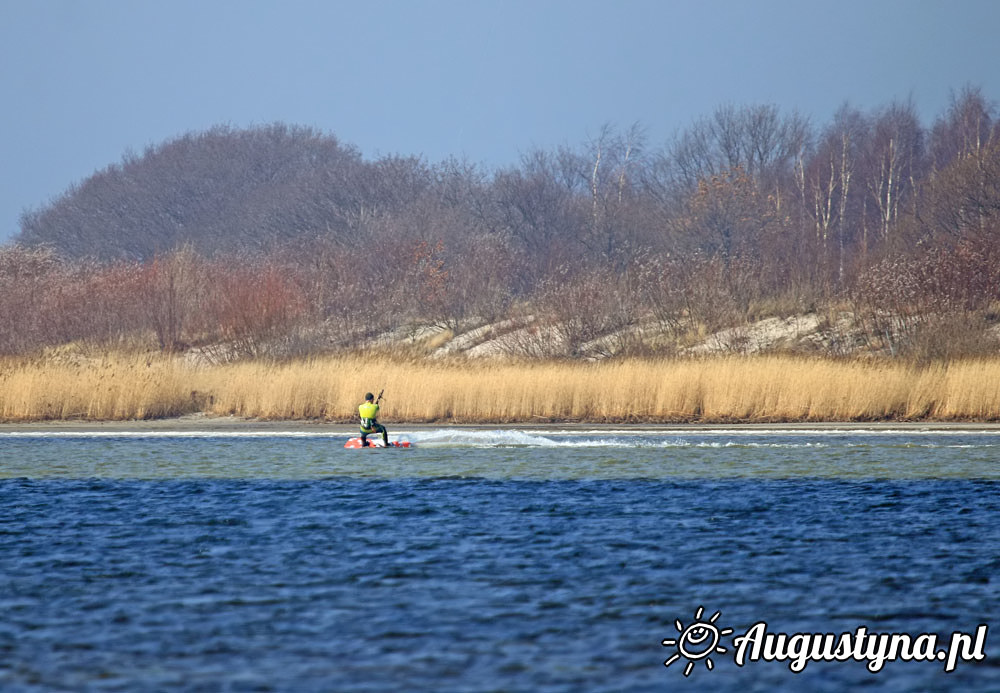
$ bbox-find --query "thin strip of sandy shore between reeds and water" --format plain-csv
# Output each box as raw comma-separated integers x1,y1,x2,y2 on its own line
0,414,1000,435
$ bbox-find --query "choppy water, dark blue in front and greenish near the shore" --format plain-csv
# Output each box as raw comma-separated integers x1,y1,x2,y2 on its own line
0,429,1000,691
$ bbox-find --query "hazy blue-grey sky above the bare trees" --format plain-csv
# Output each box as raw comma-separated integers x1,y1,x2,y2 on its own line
0,0,1000,242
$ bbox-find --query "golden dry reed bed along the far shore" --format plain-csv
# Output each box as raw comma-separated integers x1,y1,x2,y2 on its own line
0,355,1000,423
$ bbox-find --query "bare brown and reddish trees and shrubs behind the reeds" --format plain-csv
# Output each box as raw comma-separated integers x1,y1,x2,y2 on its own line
7,88,1000,357
